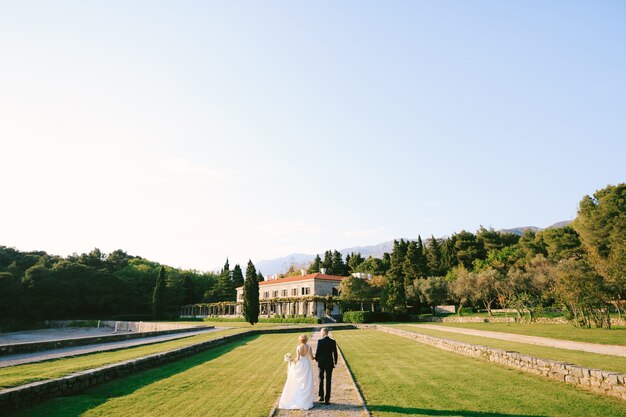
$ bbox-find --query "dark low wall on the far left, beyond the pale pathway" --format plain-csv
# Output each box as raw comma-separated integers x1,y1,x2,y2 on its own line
0,322,214,356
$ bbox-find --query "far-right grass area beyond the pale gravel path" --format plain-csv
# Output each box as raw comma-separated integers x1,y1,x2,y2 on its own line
410,323,626,346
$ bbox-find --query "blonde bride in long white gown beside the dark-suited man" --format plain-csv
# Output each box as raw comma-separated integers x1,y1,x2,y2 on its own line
278,334,314,410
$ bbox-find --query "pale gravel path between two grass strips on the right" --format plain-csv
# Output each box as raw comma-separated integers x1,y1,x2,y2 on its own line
410,324,626,357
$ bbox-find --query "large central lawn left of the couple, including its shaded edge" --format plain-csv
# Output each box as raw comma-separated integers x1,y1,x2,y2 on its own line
5,334,297,417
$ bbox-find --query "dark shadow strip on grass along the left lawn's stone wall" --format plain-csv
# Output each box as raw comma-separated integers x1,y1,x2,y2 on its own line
7,335,260,417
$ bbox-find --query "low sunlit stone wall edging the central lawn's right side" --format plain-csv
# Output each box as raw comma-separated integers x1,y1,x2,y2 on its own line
357,324,626,400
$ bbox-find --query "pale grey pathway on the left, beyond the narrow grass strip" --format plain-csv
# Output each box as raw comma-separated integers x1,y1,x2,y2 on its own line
0,328,219,368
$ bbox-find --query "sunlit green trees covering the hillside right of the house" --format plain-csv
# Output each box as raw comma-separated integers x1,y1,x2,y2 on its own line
334,184,626,327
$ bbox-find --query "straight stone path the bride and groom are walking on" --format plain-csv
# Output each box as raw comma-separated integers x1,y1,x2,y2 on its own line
270,331,370,417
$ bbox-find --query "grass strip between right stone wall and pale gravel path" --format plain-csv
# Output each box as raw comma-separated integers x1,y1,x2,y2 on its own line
393,325,626,374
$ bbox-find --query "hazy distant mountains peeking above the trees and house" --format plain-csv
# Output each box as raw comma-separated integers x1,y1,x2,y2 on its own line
256,220,572,275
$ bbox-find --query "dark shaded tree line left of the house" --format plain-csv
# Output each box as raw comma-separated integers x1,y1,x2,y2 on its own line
0,246,263,322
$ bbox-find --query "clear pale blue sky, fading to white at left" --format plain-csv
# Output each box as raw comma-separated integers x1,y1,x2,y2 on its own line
0,1,626,270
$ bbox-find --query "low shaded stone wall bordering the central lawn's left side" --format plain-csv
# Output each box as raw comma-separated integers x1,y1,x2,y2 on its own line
0,325,354,415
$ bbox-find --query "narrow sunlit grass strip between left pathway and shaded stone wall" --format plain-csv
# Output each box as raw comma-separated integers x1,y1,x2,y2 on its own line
0,328,244,388
